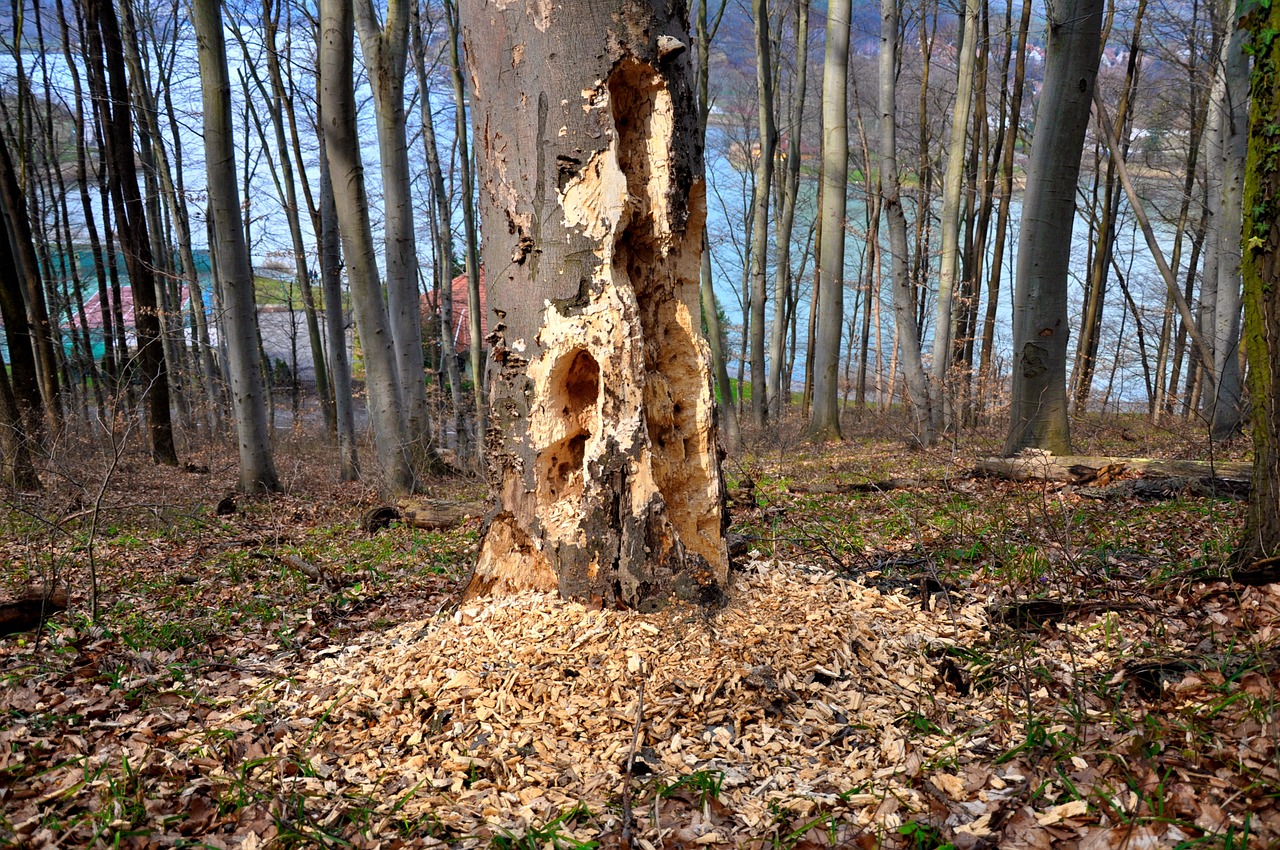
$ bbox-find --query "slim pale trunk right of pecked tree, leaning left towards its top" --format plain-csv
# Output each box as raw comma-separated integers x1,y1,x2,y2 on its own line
879,0,936,445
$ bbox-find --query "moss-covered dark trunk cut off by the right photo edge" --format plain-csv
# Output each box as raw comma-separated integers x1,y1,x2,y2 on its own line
1235,3,1280,565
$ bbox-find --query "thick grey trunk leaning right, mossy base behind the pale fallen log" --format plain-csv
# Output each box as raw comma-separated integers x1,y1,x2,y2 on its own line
1005,0,1102,454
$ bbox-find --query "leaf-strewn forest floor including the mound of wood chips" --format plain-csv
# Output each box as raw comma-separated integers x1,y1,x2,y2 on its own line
0,409,1280,849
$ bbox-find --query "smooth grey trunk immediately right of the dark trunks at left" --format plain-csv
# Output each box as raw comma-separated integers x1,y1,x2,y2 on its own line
192,0,280,493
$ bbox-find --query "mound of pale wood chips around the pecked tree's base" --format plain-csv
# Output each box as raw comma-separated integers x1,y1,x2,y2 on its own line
254,563,1003,847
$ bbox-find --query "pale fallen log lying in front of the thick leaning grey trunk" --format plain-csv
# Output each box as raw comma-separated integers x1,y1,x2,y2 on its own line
974,452,1253,484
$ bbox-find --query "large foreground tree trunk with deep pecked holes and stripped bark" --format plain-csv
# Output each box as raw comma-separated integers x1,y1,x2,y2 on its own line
463,0,728,609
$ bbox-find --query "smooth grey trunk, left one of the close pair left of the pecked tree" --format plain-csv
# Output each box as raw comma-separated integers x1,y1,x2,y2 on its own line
320,0,417,493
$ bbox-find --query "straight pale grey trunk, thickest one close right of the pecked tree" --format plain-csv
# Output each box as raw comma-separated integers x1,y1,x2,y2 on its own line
808,0,850,440
